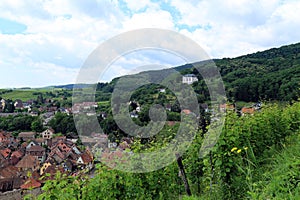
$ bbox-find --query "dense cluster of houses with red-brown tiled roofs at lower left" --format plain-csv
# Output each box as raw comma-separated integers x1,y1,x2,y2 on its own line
0,129,94,192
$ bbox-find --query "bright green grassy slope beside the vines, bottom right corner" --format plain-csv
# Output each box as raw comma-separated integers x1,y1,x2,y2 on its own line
249,132,300,200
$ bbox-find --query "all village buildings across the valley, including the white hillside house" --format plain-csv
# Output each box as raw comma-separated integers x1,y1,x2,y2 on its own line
0,74,261,196
